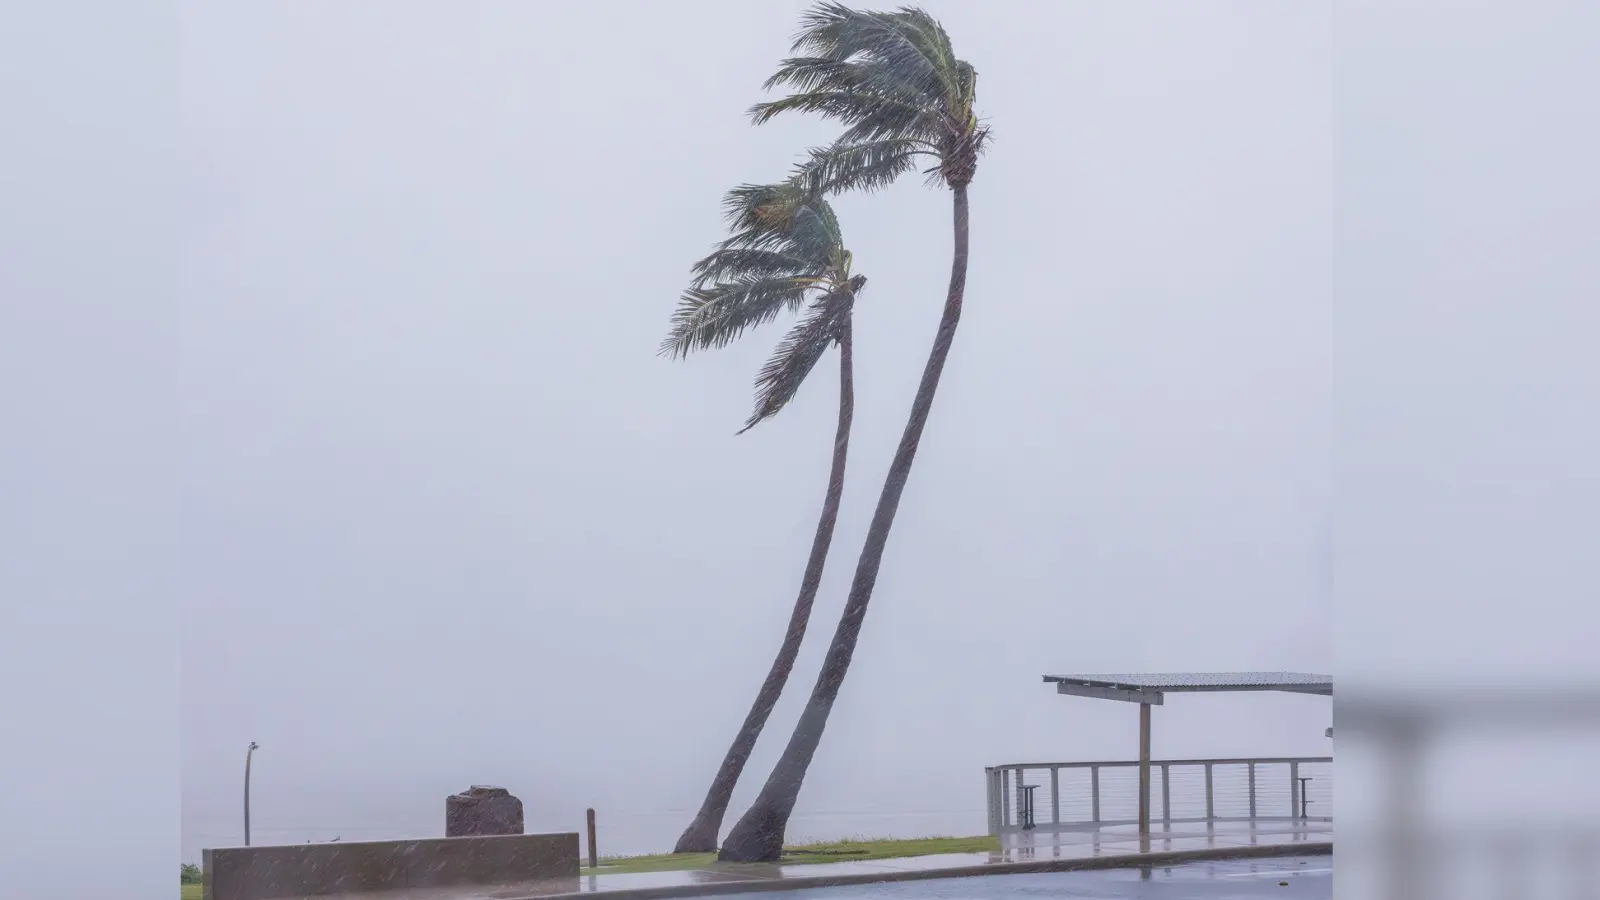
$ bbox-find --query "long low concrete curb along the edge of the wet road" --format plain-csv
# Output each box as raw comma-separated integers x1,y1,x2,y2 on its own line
518,841,1333,900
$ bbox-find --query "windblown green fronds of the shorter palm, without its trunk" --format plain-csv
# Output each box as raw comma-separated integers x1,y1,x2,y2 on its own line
661,178,866,434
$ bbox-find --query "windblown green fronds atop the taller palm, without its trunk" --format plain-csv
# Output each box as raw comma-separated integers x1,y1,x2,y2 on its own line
750,3,989,194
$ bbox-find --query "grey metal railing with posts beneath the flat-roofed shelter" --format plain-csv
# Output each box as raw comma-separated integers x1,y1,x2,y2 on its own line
984,756,1333,834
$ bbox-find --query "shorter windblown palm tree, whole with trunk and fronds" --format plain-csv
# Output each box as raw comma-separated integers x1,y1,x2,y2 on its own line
661,179,866,854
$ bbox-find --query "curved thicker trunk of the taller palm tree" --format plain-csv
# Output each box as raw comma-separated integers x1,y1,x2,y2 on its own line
717,184,968,862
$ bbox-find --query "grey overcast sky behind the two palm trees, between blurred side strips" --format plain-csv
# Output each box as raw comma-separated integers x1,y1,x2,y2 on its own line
179,0,1333,858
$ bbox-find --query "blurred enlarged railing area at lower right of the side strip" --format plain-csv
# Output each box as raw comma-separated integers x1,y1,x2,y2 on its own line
1334,677,1600,900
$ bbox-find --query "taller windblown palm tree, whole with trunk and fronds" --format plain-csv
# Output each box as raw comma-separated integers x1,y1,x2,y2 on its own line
718,3,989,862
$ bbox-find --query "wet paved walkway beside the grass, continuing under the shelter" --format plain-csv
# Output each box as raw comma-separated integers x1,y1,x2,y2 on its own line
291,822,1333,900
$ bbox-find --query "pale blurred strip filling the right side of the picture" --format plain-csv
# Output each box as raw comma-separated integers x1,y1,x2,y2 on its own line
1333,0,1600,900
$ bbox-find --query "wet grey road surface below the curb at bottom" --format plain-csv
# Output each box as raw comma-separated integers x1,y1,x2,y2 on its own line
707,857,1333,900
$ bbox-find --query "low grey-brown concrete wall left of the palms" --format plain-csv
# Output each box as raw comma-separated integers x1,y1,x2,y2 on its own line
203,833,578,900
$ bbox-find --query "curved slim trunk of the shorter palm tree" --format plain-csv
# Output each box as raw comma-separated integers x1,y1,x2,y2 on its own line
672,315,856,854
